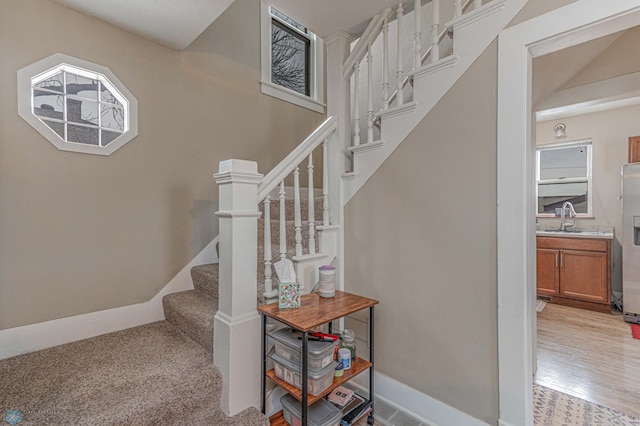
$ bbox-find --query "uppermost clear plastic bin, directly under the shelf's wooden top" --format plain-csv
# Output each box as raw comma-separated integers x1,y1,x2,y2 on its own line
271,328,338,372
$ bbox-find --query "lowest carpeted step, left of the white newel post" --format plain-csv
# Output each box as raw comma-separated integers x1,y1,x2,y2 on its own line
162,290,218,352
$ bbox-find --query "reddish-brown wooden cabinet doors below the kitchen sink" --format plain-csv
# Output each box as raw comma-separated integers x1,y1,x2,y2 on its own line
536,237,611,312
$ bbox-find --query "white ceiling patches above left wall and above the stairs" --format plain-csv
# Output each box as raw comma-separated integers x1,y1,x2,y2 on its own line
54,0,416,50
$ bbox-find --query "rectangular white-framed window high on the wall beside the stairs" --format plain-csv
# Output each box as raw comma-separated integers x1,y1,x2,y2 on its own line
261,3,324,112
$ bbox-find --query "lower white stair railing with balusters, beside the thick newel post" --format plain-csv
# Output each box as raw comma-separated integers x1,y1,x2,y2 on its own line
258,117,337,299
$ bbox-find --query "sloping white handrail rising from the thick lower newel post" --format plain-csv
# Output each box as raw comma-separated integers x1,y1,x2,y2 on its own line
258,115,338,202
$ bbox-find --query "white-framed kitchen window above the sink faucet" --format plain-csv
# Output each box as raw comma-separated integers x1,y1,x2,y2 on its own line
536,140,593,216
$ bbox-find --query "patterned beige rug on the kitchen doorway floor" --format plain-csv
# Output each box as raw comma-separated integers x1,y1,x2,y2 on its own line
533,384,640,426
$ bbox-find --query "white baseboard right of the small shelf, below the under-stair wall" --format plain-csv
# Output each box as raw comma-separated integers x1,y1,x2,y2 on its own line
353,372,488,426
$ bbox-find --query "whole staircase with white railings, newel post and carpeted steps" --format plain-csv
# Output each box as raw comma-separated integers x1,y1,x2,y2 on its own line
163,0,526,420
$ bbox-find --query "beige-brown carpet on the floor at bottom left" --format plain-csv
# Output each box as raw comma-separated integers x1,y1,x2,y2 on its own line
0,321,268,426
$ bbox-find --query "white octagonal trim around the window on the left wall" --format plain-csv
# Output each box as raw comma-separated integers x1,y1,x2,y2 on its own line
18,53,138,155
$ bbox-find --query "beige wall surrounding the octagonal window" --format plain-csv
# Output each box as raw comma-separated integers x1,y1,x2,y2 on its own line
0,0,323,329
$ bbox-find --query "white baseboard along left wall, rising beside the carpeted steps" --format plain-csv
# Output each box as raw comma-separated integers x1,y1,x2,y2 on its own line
0,237,218,359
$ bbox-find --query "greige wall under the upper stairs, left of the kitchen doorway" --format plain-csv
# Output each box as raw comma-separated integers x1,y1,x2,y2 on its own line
345,42,498,424
